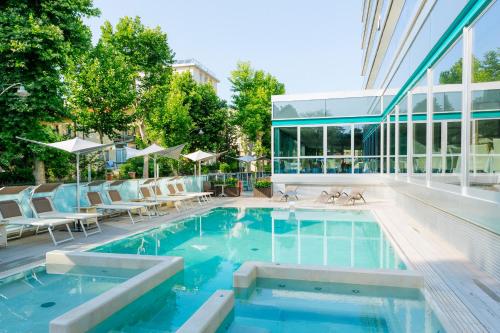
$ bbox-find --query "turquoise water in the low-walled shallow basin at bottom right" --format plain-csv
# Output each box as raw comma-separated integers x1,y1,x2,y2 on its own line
223,278,444,333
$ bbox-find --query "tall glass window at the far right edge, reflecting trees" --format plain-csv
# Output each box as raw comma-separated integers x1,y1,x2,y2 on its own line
469,1,500,198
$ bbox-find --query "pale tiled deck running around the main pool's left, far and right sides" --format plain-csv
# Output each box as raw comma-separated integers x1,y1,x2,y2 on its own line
0,196,500,332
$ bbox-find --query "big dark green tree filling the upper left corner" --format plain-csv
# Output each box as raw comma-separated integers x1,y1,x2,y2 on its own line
0,0,99,183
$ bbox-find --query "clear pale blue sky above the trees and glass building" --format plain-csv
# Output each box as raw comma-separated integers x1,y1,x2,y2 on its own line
86,0,362,101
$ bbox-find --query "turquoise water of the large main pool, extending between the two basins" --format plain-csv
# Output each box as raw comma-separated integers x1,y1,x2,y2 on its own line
93,208,405,332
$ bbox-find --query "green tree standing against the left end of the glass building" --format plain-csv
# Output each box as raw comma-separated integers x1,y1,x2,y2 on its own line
229,62,285,154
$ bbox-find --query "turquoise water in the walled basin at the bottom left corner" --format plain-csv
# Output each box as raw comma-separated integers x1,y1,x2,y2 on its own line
0,266,139,333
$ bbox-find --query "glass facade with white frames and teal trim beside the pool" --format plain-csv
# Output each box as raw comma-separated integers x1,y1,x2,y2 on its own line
273,0,500,202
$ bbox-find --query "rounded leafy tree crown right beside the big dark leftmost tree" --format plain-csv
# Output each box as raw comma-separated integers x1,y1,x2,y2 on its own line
67,41,135,143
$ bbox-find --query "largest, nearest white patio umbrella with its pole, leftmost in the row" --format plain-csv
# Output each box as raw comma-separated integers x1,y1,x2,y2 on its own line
17,137,115,212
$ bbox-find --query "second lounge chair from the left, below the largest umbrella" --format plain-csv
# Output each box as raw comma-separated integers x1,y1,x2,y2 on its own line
30,197,102,237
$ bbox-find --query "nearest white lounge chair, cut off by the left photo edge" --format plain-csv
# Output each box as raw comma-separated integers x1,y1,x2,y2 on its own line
0,200,75,245
